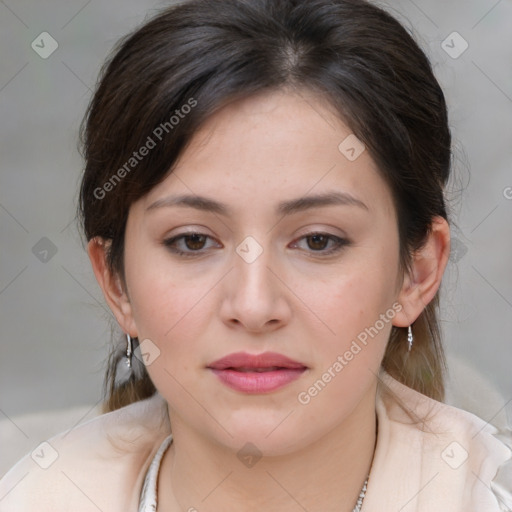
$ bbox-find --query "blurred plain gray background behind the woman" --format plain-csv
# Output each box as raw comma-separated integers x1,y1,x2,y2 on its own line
0,0,512,466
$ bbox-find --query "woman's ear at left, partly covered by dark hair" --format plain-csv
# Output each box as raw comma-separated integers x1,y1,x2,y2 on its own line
87,237,137,337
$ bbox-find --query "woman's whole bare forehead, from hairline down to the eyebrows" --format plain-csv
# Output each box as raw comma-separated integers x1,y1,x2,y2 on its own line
138,91,391,220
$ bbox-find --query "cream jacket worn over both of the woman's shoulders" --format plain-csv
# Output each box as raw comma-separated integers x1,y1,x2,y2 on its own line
0,373,512,512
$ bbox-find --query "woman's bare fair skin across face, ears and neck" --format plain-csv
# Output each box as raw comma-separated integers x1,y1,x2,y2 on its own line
88,91,449,512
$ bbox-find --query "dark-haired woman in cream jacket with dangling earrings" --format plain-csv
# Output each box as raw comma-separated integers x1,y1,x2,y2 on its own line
0,0,511,512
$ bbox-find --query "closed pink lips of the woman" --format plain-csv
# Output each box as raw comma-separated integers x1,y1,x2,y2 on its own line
208,352,307,393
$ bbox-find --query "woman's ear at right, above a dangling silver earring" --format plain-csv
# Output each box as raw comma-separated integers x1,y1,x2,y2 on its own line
393,217,450,327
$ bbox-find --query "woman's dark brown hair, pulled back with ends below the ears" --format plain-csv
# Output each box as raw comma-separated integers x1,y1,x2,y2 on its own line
79,0,451,410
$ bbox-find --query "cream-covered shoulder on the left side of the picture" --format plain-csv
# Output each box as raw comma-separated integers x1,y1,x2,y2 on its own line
0,394,170,512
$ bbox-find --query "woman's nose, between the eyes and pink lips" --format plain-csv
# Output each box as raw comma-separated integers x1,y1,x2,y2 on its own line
221,242,292,333
